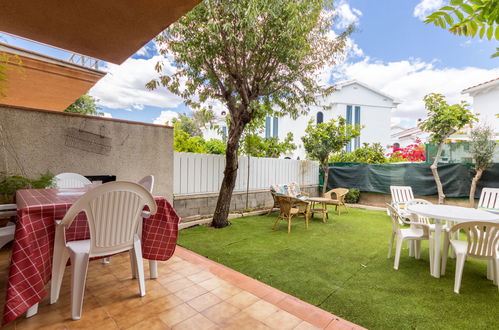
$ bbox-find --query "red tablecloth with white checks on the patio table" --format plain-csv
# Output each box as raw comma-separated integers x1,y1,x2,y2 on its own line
3,189,180,324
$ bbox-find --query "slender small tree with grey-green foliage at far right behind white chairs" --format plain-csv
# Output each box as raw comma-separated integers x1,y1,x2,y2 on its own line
470,125,496,207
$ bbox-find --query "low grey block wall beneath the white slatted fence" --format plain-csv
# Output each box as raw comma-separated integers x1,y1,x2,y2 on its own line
173,186,319,222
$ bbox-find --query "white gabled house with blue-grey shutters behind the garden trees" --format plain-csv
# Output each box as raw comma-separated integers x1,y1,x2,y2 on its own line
203,80,400,159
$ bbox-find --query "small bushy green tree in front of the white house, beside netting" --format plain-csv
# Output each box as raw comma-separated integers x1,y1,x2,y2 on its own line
301,116,360,193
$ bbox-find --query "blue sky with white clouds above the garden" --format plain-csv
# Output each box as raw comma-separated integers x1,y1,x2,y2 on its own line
0,0,499,126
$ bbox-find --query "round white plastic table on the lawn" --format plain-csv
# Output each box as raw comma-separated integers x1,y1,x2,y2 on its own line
407,204,499,278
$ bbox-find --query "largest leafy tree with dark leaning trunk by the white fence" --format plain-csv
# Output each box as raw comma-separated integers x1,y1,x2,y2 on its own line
147,0,352,227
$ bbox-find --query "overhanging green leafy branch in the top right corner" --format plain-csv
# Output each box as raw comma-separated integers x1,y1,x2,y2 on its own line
425,0,499,57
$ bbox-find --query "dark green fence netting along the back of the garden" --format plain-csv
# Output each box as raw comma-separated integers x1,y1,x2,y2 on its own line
319,163,499,198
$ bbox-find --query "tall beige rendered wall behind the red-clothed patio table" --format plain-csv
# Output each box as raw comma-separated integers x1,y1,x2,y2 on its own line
0,105,173,201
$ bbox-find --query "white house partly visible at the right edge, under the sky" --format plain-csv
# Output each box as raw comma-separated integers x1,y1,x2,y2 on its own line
461,78,499,135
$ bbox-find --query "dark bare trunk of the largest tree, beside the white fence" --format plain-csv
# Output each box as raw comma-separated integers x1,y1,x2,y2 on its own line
212,122,244,228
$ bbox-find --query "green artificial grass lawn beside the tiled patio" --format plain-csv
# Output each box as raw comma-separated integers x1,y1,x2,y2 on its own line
178,209,499,329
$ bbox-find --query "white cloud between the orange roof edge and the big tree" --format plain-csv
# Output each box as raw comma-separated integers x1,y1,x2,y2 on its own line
90,55,182,111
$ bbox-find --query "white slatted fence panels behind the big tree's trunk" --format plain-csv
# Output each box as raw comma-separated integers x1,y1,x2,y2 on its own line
173,152,319,196
